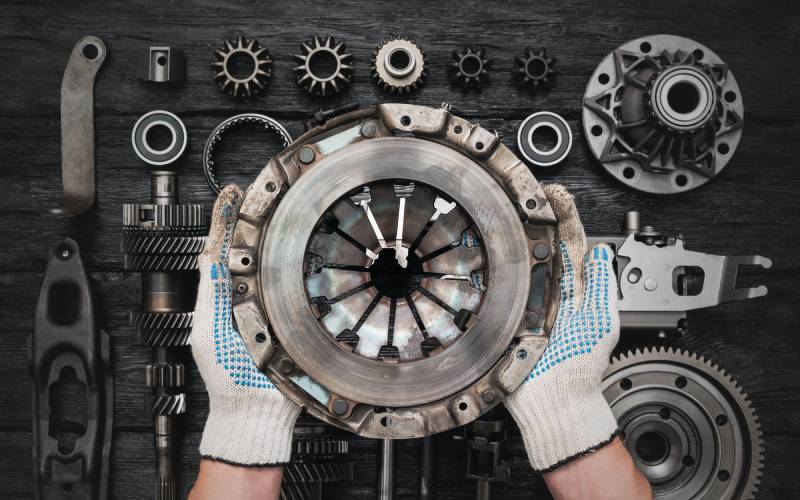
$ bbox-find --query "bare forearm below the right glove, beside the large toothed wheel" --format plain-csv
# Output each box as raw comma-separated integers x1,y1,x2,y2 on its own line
543,438,653,500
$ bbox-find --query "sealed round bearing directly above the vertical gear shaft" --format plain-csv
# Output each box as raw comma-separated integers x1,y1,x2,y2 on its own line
131,110,188,166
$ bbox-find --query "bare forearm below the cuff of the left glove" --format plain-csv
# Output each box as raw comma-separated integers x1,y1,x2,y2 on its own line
189,460,283,500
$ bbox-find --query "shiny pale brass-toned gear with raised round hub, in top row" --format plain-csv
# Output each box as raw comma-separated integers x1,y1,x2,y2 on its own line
372,36,428,94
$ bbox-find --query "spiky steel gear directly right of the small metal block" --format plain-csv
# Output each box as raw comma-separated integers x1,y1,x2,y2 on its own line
211,36,272,97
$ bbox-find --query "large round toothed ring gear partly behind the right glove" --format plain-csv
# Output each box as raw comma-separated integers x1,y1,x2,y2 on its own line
603,348,763,500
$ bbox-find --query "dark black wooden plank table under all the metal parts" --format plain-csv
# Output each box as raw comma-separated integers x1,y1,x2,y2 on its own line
0,0,800,499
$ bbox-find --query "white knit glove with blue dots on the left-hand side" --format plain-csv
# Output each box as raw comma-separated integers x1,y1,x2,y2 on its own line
190,186,300,466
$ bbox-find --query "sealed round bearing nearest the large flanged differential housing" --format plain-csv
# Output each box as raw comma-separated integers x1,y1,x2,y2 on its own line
517,111,572,167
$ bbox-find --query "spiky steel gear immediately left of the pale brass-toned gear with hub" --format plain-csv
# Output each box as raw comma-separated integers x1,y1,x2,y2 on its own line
294,35,353,97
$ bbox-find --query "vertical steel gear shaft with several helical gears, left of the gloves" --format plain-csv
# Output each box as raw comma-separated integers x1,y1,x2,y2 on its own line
121,170,208,500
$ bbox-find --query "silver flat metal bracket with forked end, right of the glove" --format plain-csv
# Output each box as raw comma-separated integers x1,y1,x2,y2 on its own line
588,212,772,333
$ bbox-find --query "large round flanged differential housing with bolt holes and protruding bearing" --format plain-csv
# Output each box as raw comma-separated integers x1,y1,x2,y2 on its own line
583,35,744,194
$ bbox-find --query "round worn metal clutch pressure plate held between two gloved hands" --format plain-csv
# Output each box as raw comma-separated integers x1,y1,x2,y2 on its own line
230,104,558,438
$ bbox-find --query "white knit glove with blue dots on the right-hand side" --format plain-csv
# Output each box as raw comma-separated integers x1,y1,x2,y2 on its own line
506,185,619,472
